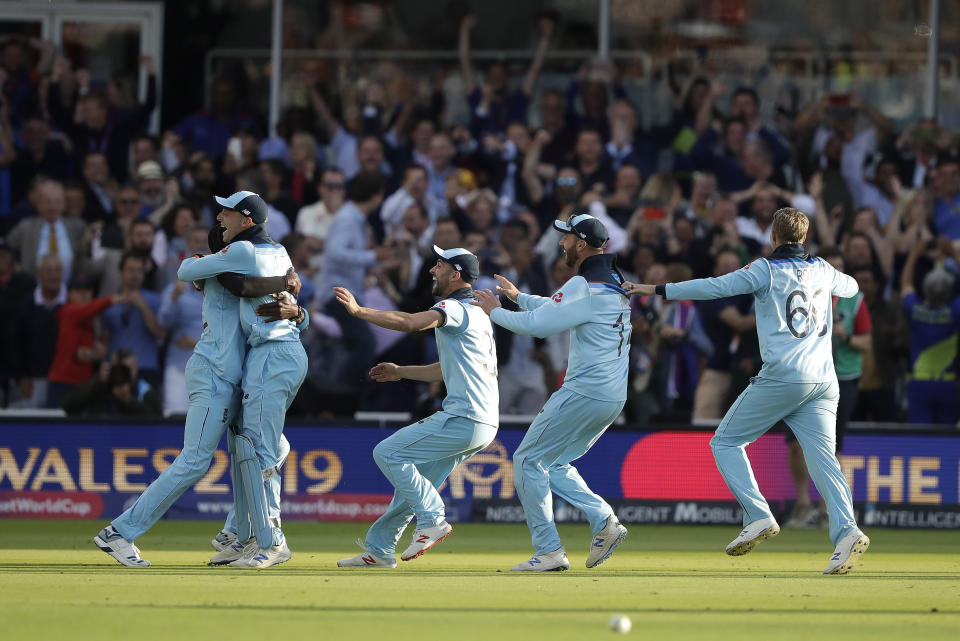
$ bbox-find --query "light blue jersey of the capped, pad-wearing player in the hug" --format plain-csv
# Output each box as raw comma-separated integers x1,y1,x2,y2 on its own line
177,233,306,347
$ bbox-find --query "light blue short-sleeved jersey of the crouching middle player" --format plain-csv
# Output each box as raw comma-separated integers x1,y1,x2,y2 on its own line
430,287,500,427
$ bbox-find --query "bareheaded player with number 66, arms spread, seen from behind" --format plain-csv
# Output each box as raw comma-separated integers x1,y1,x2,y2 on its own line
624,207,870,574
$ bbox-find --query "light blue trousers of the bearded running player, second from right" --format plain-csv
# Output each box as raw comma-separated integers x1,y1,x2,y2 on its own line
513,387,625,554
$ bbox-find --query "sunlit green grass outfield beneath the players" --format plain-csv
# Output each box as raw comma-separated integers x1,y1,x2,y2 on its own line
0,519,960,641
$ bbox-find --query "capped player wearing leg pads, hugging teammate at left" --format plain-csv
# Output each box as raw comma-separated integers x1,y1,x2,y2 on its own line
178,191,307,568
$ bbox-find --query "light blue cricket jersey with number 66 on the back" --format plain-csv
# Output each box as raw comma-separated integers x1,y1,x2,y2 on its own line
664,243,859,383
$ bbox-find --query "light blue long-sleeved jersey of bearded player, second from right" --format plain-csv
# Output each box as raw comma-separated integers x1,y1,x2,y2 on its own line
490,254,633,401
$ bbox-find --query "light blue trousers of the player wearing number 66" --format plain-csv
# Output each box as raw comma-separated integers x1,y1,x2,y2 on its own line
710,377,857,545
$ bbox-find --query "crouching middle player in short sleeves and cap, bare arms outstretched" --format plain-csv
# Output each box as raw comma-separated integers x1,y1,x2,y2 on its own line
333,246,500,568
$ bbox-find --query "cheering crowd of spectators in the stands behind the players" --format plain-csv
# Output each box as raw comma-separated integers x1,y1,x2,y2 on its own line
0,16,960,424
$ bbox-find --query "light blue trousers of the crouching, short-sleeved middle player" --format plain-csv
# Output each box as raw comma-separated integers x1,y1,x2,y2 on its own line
366,412,497,558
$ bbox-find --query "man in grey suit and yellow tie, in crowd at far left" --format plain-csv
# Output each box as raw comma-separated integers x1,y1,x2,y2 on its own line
7,180,84,282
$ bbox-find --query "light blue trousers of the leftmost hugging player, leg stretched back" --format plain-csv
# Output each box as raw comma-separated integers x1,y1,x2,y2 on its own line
113,354,240,541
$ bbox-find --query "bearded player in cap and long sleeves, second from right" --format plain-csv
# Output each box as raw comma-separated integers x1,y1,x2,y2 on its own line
475,210,631,572
